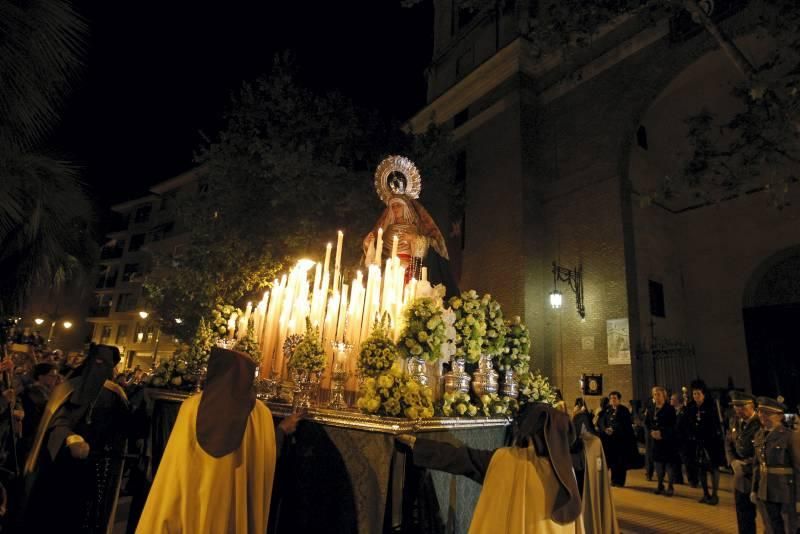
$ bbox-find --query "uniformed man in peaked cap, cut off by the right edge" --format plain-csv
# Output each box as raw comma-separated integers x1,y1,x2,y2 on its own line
750,397,800,534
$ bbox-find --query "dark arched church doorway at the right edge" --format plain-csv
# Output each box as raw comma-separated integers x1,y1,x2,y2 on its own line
742,246,800,412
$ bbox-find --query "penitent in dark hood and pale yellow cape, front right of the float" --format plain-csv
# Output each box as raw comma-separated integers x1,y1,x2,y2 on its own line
470,403,581,534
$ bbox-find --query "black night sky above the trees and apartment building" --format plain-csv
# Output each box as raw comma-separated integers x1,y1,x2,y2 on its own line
47,0,433,232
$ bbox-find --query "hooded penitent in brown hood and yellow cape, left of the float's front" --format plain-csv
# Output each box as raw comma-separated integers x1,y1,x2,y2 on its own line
137,348,276,534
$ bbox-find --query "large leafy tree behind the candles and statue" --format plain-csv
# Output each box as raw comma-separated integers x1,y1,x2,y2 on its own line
145,56,452,337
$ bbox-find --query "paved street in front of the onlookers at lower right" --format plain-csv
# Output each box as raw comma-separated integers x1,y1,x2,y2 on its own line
612,469,763,534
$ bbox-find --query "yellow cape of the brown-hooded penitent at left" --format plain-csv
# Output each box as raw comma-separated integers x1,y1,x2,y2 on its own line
136,393,276,534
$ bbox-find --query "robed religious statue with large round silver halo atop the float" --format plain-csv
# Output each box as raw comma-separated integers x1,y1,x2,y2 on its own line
363,156,458,296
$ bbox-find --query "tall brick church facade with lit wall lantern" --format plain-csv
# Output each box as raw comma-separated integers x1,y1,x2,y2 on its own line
409,0,800,407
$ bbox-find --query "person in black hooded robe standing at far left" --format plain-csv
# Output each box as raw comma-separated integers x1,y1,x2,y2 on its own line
19,345,129,534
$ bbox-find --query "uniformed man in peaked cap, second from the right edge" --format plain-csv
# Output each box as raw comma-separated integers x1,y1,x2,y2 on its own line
725,391,761,534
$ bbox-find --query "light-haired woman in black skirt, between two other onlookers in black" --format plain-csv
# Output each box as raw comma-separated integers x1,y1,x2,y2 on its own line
644,386,678,497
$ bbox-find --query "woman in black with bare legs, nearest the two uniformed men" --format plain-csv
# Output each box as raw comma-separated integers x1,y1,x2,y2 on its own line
686,380,726,505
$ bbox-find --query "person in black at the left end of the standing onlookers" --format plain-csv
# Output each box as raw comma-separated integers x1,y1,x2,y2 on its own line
597,391,639,487
